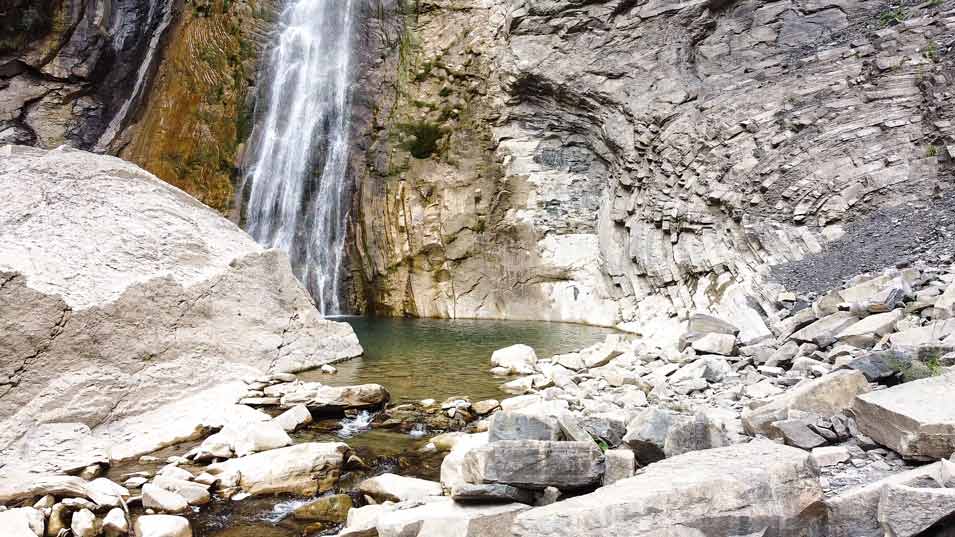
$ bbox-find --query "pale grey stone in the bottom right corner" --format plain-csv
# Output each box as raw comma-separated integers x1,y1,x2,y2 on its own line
878,484,955,537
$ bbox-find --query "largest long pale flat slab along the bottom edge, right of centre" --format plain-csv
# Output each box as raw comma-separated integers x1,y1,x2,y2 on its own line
512,440,822,537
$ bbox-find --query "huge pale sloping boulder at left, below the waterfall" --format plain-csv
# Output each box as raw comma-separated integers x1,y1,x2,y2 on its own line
0,146,361,471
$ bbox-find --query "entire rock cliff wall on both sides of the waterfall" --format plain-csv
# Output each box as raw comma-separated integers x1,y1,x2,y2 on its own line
0,0,955,348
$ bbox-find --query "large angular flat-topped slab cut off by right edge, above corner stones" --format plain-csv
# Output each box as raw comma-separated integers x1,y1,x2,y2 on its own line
852,373,955,460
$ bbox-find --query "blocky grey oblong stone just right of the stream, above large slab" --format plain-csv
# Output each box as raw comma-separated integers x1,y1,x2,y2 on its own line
464,440,604,490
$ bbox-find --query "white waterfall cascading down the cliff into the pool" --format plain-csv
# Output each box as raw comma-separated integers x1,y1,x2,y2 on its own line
243,0,353,314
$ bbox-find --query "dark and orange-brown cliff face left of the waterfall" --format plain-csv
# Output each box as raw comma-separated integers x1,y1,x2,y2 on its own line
0,0,280,213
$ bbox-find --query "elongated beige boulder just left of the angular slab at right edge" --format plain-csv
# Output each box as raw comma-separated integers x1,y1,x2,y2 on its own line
742,370,869,436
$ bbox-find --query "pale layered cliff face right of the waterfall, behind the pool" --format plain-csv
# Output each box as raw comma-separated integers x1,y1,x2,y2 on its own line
357,0,953,348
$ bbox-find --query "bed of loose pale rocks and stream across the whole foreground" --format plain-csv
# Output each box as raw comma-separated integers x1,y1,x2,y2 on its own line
0,256,955,537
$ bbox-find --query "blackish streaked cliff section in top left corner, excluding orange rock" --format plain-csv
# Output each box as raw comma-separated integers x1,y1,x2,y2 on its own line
0,0,176,148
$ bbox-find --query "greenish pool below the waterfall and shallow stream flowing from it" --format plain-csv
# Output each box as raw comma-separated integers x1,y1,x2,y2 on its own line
109,317,615,537
